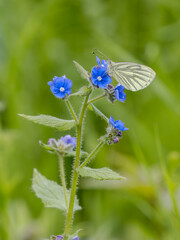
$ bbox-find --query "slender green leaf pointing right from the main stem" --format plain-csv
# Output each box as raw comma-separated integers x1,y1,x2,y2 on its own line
77,167,126,180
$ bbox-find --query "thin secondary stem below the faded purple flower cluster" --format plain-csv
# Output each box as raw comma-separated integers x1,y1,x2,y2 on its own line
59,153,68,209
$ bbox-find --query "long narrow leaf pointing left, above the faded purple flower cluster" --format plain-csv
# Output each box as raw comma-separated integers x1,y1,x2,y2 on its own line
19,114,76,131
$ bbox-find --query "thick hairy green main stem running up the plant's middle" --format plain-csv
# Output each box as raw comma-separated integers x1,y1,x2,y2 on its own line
64,95,89,237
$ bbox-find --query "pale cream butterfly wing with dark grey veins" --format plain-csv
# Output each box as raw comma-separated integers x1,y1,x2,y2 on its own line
108,61,156,91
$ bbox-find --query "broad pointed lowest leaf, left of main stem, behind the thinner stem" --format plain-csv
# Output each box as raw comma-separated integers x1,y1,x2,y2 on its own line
32,169,81,211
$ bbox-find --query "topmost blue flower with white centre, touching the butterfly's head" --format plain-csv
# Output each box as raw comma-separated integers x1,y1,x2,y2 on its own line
91,57,112,89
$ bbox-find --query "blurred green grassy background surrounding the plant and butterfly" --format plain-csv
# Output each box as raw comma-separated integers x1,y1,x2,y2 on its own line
0,0,180,240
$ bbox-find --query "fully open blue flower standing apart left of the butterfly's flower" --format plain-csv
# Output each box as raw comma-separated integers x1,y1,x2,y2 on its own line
48,75,72,98
